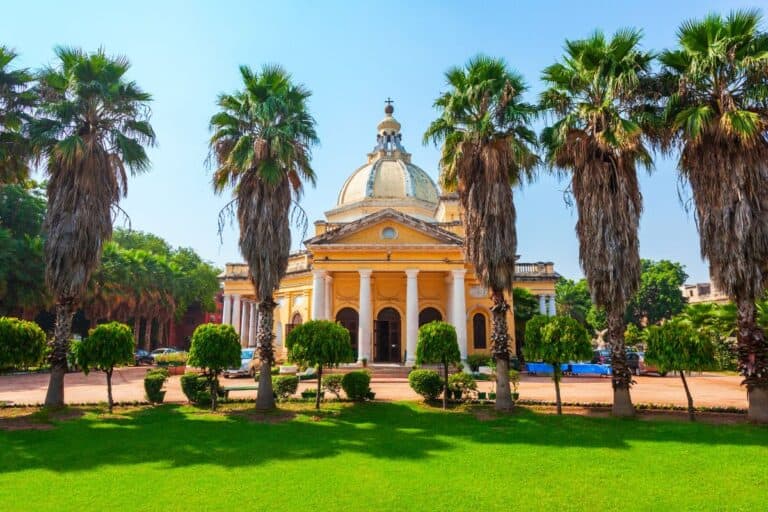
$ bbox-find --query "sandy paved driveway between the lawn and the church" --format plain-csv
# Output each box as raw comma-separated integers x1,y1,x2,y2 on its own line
0,368,747,408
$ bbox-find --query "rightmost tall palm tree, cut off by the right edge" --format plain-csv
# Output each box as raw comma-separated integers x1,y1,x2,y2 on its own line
660,11,768,422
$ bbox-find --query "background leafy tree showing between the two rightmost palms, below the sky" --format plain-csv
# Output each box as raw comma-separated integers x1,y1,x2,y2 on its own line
626,259,688,326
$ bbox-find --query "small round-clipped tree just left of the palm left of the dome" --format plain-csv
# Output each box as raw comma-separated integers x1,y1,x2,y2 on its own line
187,324,240,411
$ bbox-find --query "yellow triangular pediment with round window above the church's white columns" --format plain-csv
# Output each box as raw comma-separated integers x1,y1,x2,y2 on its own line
304,209,463,247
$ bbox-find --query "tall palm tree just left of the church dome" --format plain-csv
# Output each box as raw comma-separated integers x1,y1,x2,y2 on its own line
210,65,318,409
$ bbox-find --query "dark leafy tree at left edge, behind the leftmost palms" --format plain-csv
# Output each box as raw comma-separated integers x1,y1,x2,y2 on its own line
0,182,49,316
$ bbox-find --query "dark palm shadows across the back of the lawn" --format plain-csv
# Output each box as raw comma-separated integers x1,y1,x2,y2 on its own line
0,402,768,472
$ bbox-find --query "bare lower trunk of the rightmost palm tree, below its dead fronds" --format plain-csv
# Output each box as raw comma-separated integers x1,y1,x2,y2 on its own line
736,297,768,423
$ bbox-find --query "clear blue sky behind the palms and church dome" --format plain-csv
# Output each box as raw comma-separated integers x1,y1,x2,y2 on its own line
0,0,755,281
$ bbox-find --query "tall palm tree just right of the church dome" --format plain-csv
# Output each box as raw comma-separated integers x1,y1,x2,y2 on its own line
424,55,539,410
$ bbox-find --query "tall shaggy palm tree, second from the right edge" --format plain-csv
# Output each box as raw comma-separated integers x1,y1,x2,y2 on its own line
541,30,653,416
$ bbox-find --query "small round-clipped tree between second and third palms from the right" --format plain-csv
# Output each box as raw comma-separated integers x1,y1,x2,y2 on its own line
525,316,592,414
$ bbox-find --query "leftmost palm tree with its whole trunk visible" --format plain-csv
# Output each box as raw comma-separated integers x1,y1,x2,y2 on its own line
31,47,155,406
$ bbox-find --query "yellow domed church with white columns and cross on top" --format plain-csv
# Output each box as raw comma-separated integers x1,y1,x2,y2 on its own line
222,104,559,364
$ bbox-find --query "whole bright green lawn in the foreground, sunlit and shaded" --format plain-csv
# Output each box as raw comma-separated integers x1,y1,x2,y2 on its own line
0,403,768,512
